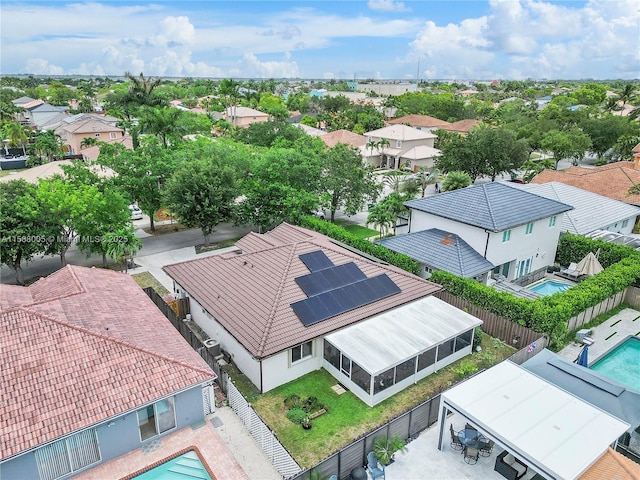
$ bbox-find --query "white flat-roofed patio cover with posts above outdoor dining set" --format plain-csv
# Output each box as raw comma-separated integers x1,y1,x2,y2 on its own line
438,360,629,480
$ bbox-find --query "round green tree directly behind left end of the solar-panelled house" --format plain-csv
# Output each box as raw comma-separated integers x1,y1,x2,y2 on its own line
163,158,238,245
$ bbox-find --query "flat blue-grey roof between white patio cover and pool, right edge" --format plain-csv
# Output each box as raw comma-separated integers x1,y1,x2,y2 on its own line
522,349,640,430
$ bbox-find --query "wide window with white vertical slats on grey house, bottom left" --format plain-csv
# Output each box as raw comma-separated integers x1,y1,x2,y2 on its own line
35,428,100,480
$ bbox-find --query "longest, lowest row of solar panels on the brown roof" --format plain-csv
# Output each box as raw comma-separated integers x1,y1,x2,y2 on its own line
291,273,401,327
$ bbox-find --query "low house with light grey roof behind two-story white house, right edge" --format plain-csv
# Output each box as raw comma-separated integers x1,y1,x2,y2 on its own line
505,182,640,235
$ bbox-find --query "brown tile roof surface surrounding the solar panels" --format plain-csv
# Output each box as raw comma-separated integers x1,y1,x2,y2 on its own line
164,224,441,358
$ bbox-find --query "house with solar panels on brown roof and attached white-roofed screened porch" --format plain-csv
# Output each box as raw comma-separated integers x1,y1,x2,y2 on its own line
164,223,481,405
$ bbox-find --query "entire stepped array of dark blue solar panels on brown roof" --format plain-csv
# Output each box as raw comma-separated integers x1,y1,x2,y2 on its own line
291,251,400,327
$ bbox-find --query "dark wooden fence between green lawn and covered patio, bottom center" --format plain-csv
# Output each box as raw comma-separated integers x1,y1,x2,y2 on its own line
291,395,440,480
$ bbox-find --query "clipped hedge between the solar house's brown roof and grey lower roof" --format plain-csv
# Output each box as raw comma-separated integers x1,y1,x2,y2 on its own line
299,216,420,275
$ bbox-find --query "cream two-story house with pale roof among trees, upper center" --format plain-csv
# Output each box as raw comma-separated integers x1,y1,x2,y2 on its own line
360,125,441,172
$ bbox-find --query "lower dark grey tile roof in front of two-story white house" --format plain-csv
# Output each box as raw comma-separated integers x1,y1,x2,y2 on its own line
375,228,494,278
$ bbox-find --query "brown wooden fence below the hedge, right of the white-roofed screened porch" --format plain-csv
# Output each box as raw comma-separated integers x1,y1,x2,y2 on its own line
434,290,544,348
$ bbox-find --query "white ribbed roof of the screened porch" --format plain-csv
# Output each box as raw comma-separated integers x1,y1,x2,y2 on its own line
325,297,482,375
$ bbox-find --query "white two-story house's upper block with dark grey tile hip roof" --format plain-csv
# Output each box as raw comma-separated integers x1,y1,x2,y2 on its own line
405,182,573,280
